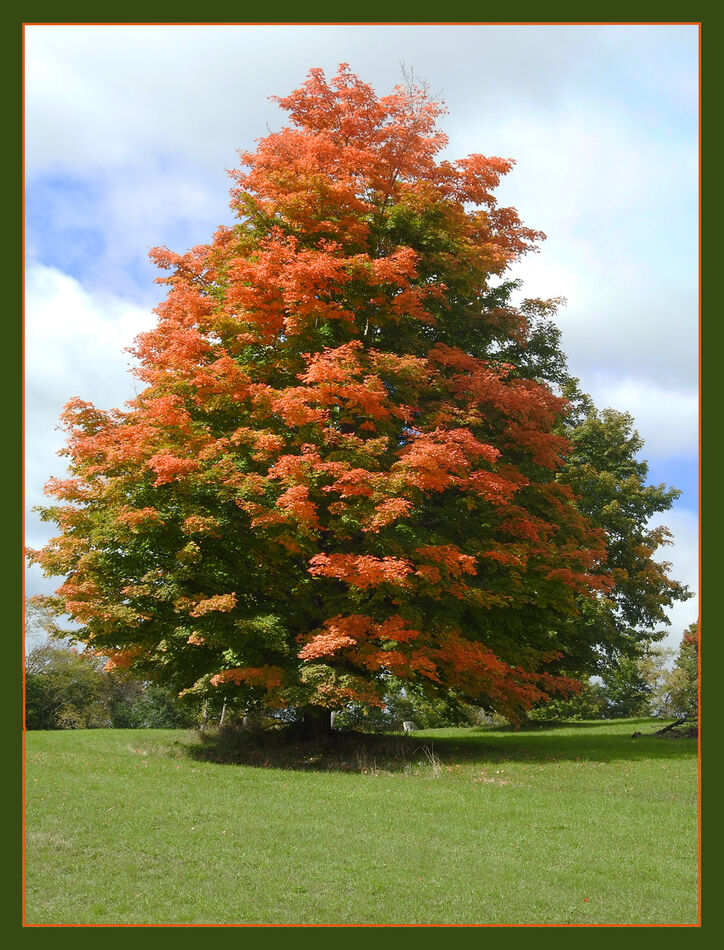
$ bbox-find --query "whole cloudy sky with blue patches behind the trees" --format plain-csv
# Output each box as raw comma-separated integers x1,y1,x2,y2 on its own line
25,24,699,646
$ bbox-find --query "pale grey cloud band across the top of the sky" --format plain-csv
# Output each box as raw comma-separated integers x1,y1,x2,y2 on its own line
26,24,697,178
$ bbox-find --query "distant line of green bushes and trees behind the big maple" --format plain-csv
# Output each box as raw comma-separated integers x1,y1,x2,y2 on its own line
25,601,698,731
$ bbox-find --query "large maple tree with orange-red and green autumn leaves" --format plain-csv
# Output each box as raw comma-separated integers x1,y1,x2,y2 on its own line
32,66,624,719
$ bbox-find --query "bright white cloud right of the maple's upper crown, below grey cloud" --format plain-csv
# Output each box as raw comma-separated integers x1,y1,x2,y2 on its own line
464,100,698,392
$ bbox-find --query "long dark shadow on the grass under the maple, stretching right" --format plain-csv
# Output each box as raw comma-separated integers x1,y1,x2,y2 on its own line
188,719,697,774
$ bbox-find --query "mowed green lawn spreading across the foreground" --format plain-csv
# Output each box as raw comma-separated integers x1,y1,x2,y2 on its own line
26,720,697,926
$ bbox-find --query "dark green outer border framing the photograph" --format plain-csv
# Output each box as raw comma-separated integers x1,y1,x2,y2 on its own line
5,0,708,948
